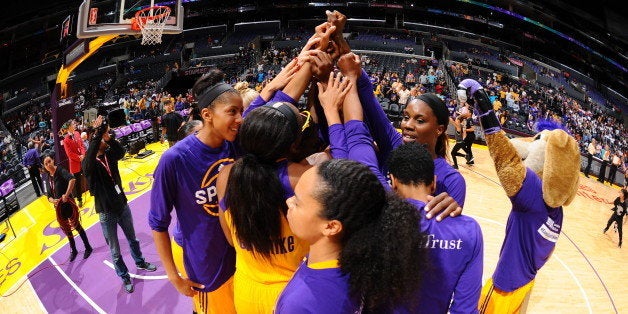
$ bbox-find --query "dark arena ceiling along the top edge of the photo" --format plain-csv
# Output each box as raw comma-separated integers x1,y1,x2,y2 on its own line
0,0,628,95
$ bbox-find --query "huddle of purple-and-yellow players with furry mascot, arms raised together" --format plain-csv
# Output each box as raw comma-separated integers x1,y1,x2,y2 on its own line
148,11,579,313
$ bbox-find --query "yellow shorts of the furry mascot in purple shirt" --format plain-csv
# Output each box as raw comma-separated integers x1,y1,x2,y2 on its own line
478,278,534,314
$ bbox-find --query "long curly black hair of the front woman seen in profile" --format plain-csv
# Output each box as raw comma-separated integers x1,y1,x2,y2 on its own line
314,159,427,312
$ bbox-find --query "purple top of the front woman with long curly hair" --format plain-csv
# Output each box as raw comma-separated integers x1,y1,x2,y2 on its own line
275,262,359,314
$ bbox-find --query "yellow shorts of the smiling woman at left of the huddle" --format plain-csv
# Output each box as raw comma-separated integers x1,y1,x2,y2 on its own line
171,239,236,314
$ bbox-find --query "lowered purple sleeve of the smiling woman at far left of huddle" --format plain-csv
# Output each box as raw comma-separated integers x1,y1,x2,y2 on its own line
148,159,177,232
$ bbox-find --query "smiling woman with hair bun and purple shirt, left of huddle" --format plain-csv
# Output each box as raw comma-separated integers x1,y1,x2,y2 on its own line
149,69,243,313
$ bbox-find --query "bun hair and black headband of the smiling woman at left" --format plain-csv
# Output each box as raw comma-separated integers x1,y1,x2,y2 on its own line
192,68,240,109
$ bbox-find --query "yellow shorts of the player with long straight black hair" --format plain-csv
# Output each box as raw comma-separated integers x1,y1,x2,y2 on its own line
233,270,288,314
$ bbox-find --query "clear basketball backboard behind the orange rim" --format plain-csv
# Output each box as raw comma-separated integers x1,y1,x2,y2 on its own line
76,0,184,38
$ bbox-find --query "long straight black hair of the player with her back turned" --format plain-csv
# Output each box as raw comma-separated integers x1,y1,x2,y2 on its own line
226,104,298,258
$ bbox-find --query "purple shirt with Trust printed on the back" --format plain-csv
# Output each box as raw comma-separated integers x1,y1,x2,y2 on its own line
407,199,484,313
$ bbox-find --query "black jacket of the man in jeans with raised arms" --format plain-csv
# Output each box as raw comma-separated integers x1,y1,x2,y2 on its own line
83,130,127,213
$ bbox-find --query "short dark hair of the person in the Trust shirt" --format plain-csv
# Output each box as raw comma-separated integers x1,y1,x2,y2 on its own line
388,142,434,185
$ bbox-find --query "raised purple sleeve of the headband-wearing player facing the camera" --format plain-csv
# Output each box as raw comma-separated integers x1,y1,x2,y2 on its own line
357,70,402,160
